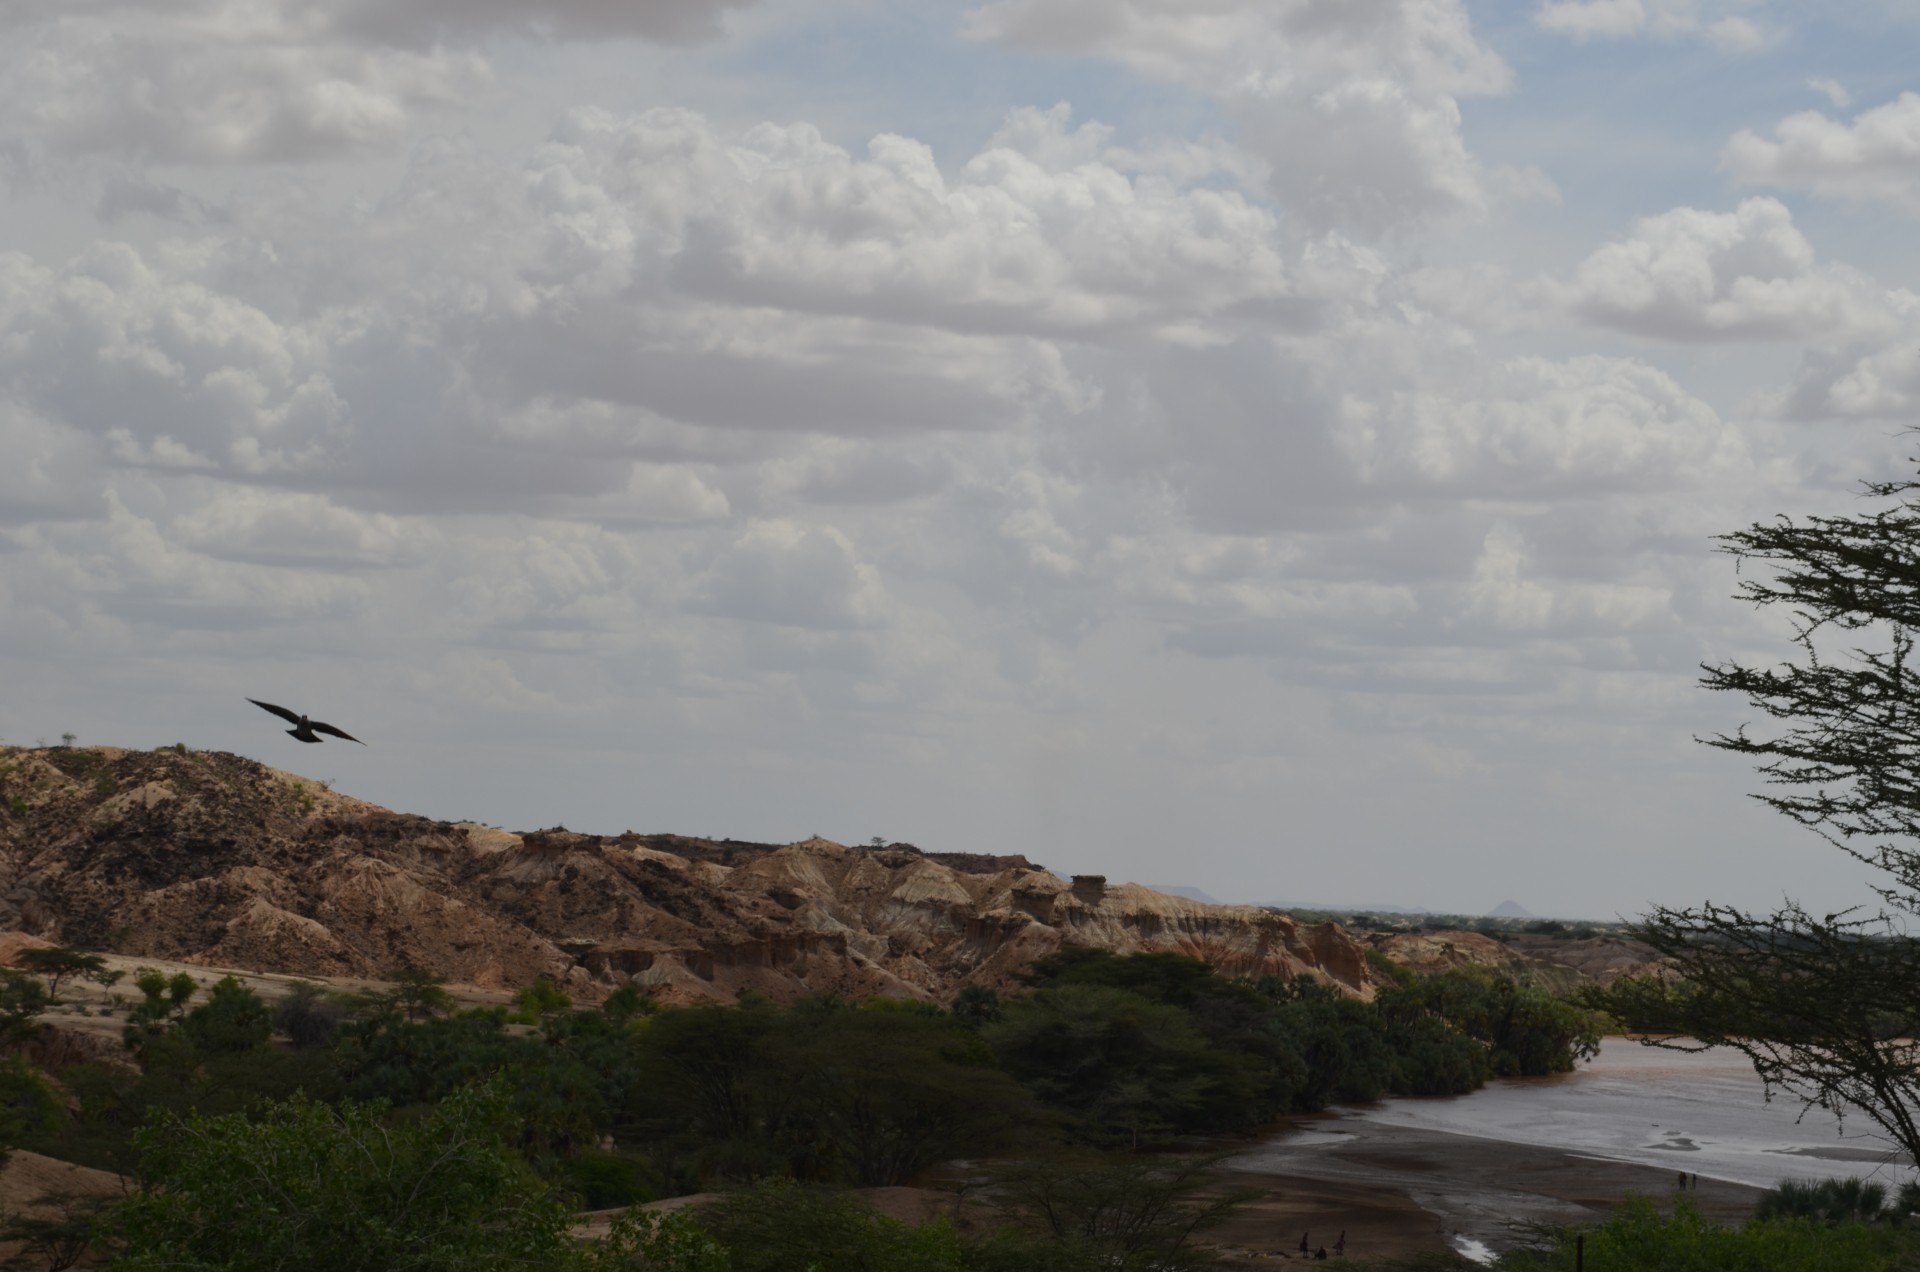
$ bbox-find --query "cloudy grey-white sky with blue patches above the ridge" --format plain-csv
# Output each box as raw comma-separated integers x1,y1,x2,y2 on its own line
0,0,1920,918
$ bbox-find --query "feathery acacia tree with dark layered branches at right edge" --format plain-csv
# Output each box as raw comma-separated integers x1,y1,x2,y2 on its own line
1609,468,1920,1161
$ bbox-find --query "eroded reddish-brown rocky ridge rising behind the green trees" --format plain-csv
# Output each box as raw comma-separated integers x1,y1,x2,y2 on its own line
0,747,1371,999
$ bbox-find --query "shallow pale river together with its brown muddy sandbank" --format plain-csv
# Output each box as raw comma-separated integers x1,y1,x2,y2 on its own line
1229,1038,1912,1257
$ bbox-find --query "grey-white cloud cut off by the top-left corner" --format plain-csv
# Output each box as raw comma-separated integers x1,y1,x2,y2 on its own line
0,0,755,165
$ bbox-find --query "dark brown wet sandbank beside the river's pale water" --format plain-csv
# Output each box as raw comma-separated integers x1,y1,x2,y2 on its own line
1208,1114,1761,1266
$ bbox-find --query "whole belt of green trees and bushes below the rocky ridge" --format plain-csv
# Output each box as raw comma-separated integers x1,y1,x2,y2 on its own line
0,949,1599,1272
